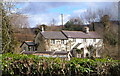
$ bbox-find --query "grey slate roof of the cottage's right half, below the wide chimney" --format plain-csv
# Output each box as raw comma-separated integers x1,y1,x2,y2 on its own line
62,31,101,38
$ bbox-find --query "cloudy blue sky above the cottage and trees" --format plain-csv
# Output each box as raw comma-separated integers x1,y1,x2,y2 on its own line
15,2,117,27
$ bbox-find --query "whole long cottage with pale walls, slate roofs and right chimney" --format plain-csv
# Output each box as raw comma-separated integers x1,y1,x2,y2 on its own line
35,27,103,57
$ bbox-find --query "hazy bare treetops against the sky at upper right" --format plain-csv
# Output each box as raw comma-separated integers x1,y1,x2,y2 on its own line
82,3,118,23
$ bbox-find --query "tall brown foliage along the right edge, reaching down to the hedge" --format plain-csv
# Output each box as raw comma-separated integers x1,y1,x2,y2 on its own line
100,15,120,59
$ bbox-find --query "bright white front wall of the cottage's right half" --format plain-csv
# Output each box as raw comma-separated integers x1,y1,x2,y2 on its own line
66,38,103,57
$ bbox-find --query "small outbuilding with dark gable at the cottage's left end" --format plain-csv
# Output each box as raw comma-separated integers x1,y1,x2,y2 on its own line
20,41,36,51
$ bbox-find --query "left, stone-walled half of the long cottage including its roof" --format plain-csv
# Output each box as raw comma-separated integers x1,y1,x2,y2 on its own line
35,31,67,51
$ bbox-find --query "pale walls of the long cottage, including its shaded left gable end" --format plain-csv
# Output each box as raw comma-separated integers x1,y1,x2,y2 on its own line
35,31,103,57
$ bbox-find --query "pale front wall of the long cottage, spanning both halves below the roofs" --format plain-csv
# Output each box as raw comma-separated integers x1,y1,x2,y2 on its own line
34,35,103,57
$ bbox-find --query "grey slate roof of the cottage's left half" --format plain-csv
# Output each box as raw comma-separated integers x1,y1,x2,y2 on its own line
41,31,67,39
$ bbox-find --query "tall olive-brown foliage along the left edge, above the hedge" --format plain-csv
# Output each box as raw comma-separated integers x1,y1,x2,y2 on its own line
0,3,17,53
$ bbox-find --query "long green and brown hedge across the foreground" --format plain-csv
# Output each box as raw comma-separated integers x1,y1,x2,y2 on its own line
2,53,120,76
